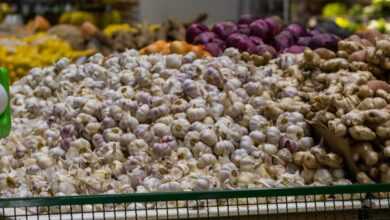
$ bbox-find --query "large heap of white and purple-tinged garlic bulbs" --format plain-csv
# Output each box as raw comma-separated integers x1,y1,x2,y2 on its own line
0,49,351,197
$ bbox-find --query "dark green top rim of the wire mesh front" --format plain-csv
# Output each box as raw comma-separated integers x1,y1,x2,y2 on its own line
0,183,390,208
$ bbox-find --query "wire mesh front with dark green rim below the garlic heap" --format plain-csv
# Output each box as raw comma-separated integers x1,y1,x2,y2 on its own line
0,184,390,220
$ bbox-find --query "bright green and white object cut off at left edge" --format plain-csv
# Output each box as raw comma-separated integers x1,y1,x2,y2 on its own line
0,68,11,138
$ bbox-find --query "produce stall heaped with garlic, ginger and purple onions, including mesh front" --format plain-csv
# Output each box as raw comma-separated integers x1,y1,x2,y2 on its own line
0,1,390,220
